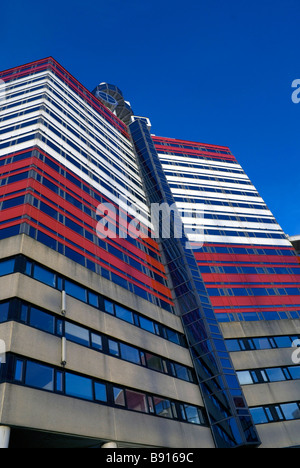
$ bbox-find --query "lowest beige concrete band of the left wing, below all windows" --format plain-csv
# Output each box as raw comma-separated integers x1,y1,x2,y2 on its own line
0,384,214,448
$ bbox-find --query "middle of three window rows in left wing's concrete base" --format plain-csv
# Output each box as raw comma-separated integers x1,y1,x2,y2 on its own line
0,299,196,383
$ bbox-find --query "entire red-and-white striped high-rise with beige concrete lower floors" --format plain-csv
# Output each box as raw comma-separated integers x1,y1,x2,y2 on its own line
0,58,300,448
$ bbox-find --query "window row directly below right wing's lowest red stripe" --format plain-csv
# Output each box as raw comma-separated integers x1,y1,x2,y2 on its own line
216,306,300,323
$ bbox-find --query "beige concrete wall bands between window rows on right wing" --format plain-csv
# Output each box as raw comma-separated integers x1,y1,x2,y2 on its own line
221,320,300,448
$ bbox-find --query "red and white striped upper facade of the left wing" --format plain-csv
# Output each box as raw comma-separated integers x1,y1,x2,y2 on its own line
0,58,173,309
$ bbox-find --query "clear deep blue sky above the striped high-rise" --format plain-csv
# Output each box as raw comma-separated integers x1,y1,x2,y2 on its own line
0,0,300,235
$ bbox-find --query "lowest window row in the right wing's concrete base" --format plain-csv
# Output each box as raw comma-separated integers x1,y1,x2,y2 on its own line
250,402,300,424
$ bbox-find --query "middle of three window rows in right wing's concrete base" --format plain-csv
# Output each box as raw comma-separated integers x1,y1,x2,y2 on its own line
237,366,300,385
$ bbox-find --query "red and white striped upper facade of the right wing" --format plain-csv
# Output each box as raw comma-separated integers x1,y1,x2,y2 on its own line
153,136,300,321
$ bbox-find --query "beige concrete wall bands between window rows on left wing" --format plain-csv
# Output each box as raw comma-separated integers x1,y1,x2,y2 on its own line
0,236,214,448
